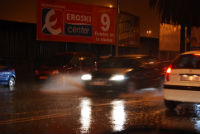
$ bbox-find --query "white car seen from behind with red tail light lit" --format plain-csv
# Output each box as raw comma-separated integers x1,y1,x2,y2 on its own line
163,51,200,109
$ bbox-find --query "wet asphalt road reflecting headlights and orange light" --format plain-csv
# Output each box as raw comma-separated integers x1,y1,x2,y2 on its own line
0,76,200,134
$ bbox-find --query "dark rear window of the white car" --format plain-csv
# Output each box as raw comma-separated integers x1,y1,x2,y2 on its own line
173,54,200,69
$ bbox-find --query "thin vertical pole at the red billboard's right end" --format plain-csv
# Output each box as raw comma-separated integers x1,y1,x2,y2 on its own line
115,0,120,56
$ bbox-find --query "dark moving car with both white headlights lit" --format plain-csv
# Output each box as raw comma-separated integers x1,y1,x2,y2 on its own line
81,54,163,92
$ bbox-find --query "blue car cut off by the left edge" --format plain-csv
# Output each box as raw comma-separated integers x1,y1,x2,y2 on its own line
0,59,16,87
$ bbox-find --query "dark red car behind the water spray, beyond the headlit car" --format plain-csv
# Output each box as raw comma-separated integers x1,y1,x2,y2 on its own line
35,52,96,80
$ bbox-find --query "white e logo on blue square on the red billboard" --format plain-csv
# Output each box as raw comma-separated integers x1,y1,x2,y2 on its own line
42,8,62,35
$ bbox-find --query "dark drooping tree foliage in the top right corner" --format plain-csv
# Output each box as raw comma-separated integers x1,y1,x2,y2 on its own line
149,0,200,26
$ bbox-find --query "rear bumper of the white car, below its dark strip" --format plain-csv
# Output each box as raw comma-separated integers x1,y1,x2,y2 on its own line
163,85,200,103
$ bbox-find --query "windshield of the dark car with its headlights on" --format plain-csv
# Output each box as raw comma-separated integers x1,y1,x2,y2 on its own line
98,58,139,68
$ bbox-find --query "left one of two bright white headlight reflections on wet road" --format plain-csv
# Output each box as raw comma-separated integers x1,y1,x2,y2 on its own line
80,98,92,133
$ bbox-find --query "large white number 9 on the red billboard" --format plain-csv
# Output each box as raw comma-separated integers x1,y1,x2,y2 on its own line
101,13,110,32
